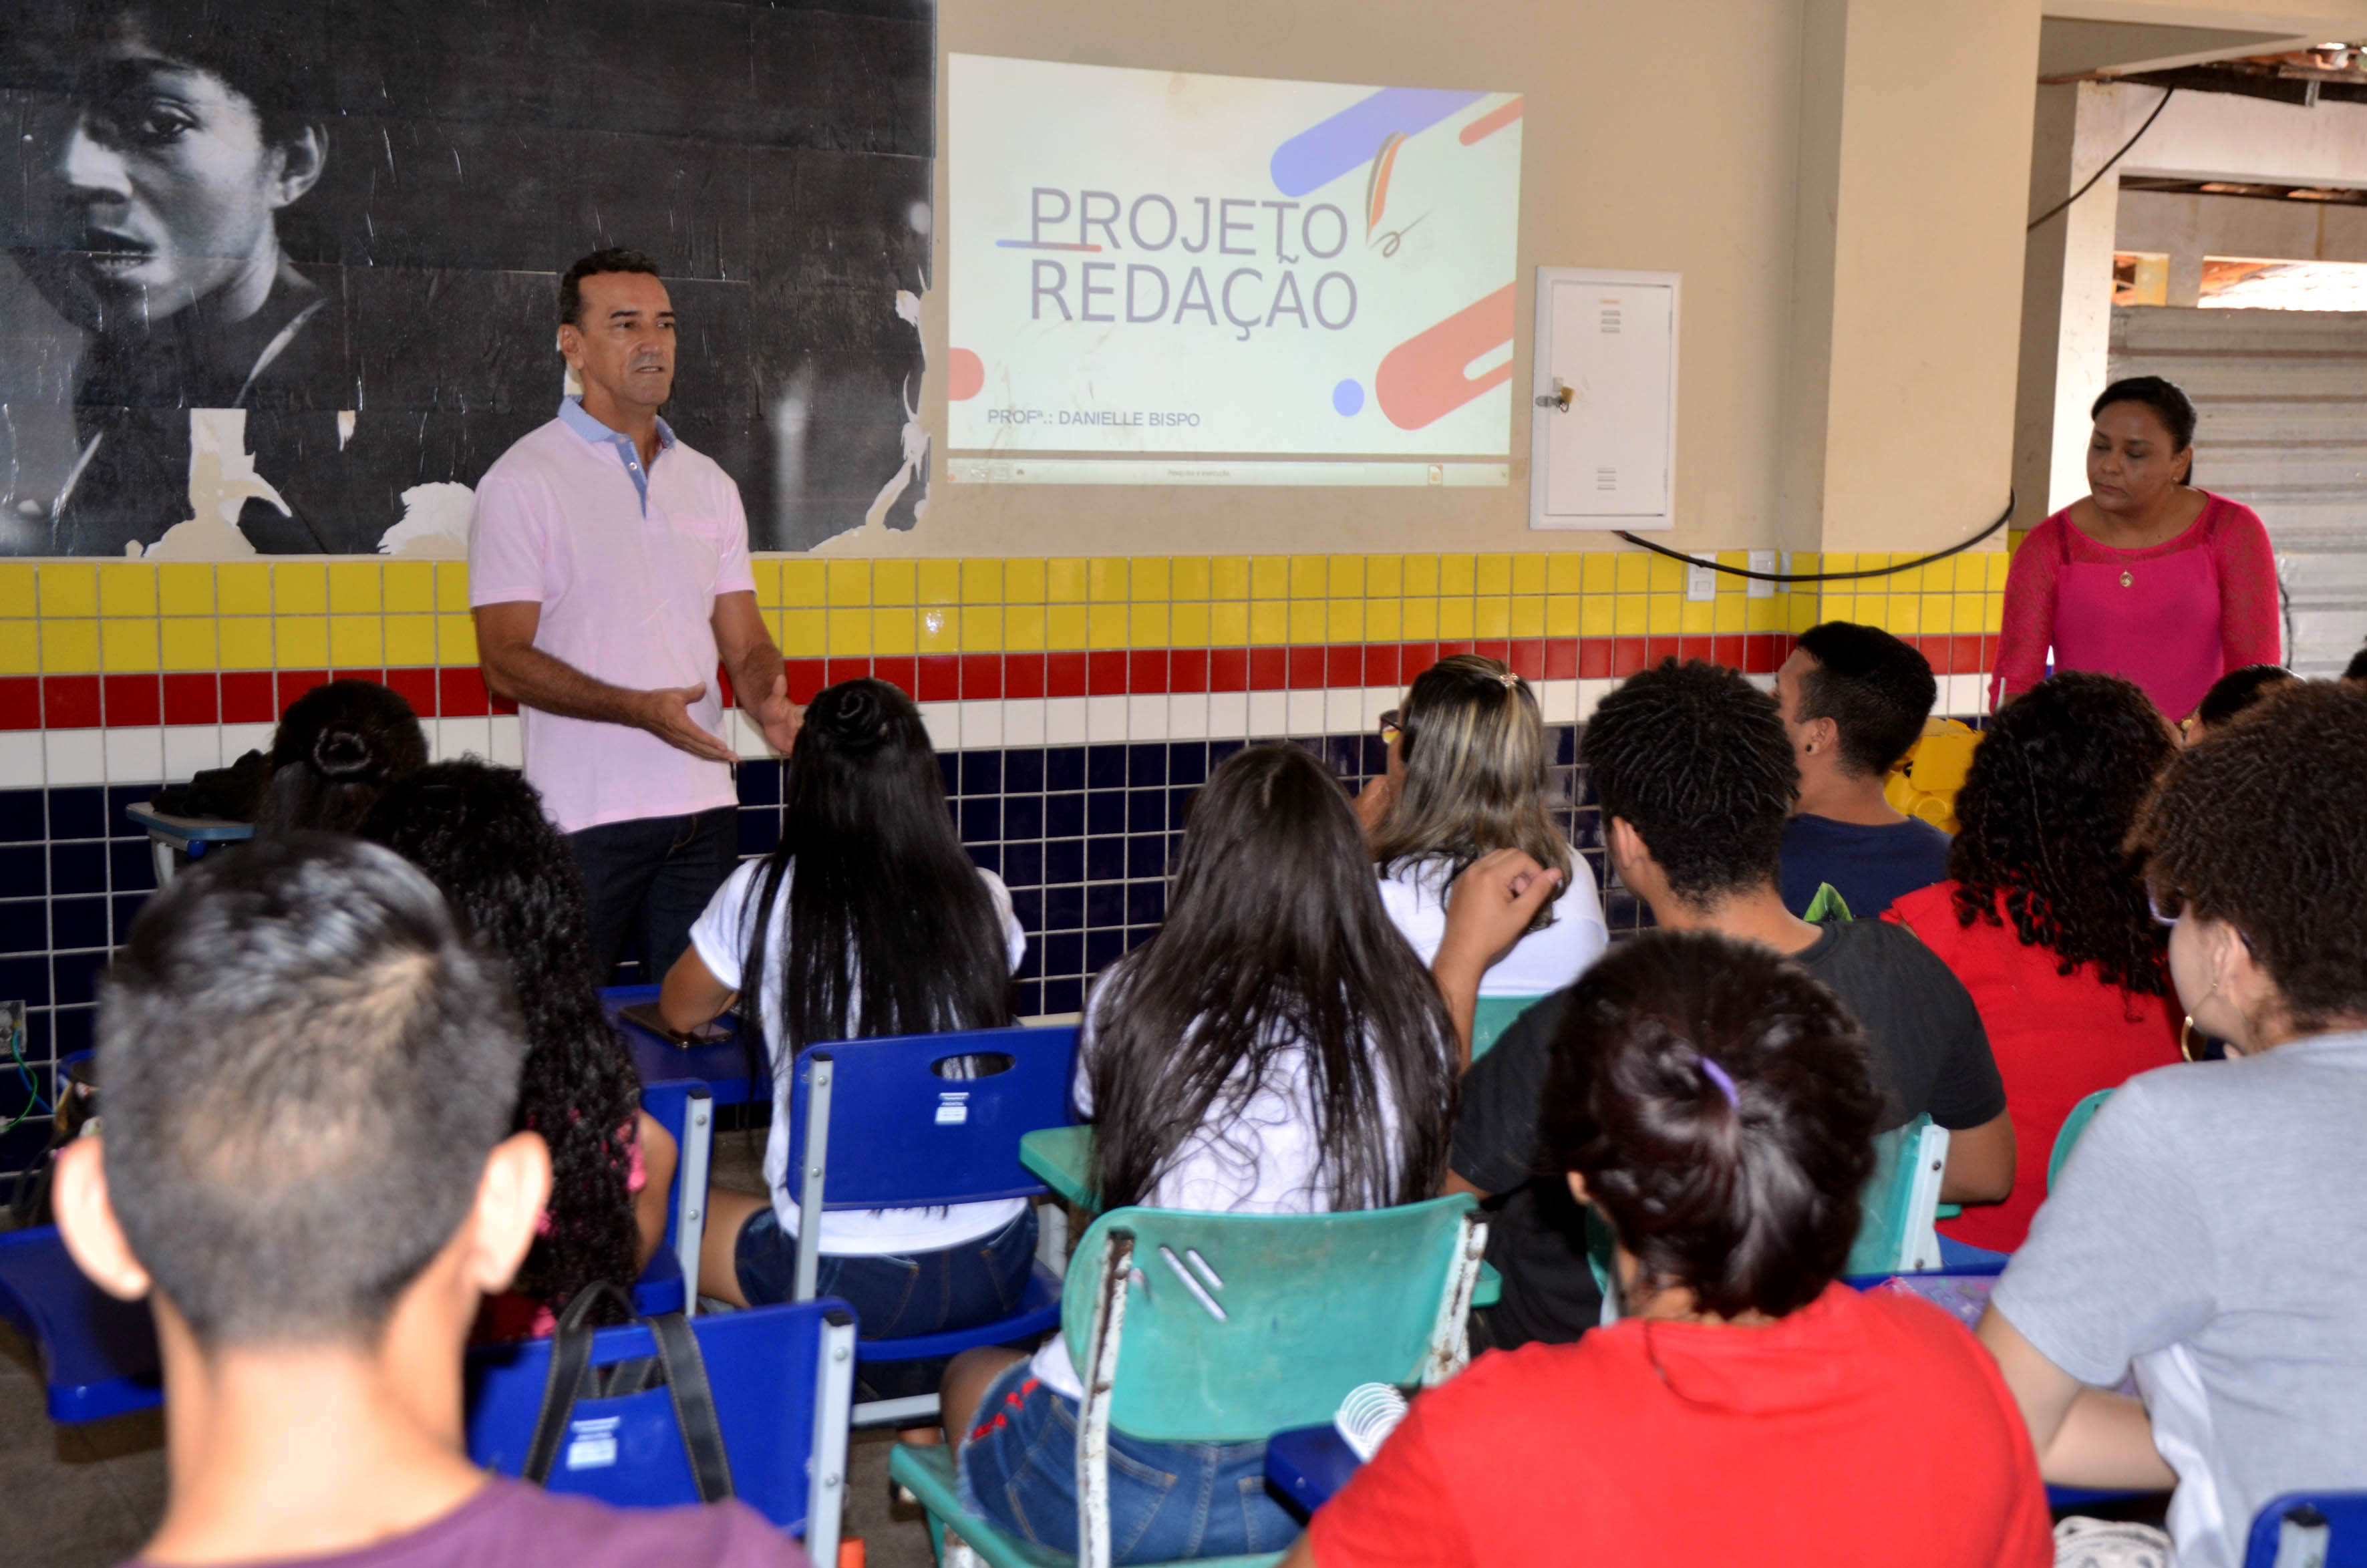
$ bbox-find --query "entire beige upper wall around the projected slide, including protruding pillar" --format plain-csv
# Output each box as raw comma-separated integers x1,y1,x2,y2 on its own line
856,0,2038,555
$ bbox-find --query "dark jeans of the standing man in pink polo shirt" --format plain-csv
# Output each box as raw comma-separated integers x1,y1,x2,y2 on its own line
568,805,738,985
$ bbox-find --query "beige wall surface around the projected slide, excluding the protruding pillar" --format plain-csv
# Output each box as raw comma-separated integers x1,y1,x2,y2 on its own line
826,0,1799,555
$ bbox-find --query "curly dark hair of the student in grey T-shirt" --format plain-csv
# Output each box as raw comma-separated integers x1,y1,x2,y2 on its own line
2139,677,2367,1033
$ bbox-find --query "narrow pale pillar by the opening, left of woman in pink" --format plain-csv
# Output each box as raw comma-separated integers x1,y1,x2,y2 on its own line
2014,83,2130,533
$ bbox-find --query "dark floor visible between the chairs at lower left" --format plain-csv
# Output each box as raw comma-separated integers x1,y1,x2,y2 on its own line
0,1132,933,1568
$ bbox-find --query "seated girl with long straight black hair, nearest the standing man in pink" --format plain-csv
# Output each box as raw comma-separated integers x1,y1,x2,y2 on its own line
658,680,1037,1345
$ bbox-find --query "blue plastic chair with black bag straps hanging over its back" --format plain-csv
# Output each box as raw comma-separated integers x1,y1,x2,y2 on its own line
466,1300,854,1565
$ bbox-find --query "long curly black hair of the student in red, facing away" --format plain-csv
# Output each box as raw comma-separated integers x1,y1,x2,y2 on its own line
1948,670,2178,997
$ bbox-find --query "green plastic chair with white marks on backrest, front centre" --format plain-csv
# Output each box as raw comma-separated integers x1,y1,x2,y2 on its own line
888,1194,1486,1568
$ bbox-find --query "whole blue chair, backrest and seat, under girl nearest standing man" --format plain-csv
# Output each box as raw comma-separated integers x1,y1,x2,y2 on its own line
788,1024,1077,1424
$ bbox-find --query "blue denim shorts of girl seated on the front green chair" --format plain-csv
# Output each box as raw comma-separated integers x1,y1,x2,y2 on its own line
956,1362,1299,1563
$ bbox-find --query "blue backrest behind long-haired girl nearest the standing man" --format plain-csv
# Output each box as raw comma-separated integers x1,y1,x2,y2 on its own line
788,1024,1077,1208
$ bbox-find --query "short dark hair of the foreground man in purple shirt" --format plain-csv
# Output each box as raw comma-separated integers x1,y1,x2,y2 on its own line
100,834,526,1346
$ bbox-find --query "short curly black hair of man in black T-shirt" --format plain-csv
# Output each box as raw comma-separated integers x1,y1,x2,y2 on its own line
1579,659,1799,903
